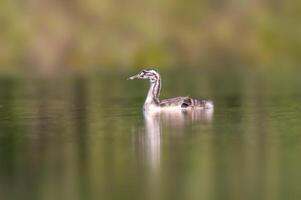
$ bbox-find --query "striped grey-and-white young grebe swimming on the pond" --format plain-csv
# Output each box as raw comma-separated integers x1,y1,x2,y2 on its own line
127,69,214,111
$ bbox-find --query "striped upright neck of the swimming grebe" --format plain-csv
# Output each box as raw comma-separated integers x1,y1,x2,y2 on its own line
144,77,161,105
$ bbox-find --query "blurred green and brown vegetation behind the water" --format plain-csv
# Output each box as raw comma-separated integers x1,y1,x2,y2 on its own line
0,0,301,72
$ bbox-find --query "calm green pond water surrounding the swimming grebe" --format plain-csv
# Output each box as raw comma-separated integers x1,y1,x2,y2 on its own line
0,71,301,200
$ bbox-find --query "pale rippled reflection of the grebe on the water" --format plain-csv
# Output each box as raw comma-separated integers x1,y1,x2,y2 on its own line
139,110,213,169
